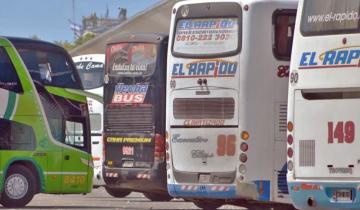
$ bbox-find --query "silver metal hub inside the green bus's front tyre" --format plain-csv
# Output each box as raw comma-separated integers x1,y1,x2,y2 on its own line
5,174,29,199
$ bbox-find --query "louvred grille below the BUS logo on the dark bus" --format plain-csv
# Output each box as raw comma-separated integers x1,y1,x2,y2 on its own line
104,105,155,132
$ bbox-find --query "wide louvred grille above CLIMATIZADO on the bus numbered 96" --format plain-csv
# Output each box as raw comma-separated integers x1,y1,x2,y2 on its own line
173,98,235,119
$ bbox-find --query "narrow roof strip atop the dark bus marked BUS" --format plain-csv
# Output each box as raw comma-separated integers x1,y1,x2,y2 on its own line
108,33,168,45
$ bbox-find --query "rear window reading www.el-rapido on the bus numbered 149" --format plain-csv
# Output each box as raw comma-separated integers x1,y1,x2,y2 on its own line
301,0,360,36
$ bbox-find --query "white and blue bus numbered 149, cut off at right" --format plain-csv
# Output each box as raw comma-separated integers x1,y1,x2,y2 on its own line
287,0,360,209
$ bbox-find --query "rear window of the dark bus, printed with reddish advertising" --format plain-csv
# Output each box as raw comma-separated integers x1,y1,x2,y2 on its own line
107,43,157,77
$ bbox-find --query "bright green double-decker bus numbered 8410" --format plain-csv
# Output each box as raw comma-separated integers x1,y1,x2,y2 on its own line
0,38,93,207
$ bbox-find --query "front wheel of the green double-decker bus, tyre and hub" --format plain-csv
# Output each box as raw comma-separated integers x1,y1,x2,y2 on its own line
0,165,36,208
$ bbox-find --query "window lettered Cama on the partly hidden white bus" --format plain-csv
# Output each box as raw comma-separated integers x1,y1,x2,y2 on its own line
76,61,104,90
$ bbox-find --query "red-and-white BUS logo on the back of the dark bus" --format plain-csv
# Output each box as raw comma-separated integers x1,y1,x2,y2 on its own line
112,84,149,104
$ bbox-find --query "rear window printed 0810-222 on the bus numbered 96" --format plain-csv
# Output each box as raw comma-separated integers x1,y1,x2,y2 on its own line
173,18,239,56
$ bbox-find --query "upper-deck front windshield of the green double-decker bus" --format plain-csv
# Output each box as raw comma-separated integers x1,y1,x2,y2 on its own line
14,42,82,89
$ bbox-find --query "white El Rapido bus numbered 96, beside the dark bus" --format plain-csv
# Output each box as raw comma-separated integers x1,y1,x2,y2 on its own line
166,0,297,207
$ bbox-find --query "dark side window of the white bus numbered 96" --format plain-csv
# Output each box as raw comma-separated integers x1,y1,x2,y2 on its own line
273,10,296,61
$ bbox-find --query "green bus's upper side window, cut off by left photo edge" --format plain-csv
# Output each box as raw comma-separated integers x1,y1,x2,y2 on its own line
0,47,23,93
